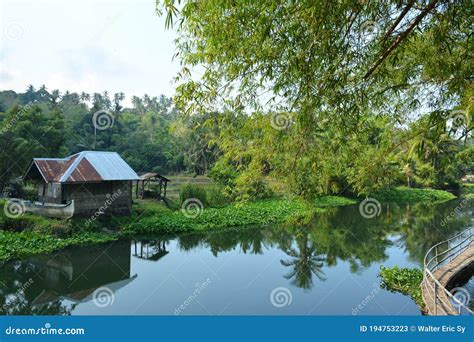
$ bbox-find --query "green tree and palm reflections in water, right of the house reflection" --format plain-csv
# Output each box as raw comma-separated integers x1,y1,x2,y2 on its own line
178,201,472,288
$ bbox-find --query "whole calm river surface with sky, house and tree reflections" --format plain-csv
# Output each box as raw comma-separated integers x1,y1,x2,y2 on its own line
0,200,474,315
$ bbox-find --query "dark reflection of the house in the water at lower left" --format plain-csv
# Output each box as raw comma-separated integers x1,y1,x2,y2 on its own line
0,241,136,315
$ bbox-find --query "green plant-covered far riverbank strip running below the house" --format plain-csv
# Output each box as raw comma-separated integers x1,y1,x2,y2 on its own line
0,188,455,261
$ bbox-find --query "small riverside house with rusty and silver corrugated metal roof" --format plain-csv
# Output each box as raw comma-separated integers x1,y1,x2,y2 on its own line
23,151,139,217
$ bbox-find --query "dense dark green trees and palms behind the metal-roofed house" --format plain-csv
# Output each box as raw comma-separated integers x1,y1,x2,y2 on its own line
0,86,218,190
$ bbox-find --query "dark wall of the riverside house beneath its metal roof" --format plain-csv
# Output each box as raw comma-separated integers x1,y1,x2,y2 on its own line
62,181,132,216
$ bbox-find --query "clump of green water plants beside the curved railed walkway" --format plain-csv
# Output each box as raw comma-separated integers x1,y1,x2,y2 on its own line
379,266,425,311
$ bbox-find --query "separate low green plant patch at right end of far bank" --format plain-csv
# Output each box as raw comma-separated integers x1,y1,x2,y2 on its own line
373,186,456,203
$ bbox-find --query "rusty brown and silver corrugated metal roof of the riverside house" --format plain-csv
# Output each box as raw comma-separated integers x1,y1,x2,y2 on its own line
27,151,138,183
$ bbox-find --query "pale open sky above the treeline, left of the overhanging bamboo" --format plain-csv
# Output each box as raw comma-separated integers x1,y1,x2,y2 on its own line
0,0,179,103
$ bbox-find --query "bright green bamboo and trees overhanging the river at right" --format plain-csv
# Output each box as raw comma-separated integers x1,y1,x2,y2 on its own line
158,0,474,199
